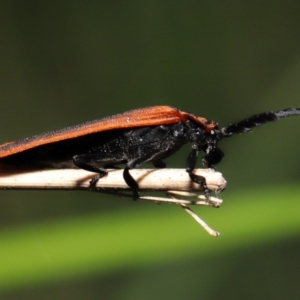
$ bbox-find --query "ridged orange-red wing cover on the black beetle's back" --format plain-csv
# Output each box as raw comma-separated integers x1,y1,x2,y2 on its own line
0,106,186,158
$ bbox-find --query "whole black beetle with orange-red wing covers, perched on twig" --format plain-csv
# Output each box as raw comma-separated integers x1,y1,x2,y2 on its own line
0,106,300,199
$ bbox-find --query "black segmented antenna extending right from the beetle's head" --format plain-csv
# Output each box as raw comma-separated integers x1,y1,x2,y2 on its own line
221,108,300,137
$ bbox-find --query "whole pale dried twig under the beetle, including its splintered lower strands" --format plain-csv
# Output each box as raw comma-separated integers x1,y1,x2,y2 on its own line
0,168,226,236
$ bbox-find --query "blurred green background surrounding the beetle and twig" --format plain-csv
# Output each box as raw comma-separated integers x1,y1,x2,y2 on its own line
0,0,300,300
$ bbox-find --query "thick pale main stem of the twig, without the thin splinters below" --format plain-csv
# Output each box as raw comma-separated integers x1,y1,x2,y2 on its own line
0,166,226,191
